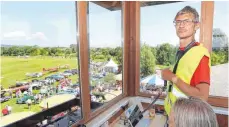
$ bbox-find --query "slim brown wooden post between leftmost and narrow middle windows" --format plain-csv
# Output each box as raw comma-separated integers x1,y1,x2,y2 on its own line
77,1,91,121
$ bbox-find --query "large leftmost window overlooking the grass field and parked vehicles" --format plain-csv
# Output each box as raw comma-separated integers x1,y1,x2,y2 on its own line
0,2,81,125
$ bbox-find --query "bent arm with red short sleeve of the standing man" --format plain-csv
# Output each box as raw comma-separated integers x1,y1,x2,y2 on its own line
162,57,210,100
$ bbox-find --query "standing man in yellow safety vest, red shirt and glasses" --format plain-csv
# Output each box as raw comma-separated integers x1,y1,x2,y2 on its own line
161,6,210,114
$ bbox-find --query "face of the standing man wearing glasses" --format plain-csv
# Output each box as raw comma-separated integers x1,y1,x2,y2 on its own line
175,13,199,39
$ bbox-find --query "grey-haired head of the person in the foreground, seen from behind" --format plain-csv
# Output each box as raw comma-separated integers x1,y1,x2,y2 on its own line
169,97,218,127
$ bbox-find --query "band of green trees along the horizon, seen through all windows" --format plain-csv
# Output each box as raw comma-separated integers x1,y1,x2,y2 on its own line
1,43,228,76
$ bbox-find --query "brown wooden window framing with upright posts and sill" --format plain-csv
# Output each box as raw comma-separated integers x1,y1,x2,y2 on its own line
73,1,228,126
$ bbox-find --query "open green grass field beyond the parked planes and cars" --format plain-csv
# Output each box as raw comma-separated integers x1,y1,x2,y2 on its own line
1,56,78,89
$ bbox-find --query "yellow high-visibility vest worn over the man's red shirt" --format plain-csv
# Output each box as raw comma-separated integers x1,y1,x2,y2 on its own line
164,43,211,115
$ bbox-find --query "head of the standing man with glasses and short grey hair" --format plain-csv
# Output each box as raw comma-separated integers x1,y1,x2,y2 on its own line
173,6,200,39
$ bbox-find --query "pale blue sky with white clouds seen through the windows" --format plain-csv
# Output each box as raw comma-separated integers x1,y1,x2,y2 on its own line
0,1,229,47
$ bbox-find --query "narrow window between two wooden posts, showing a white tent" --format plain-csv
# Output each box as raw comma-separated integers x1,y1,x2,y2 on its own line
88,2,123,111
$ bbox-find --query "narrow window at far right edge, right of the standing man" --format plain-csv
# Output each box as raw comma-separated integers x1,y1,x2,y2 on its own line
210,1,229,97
